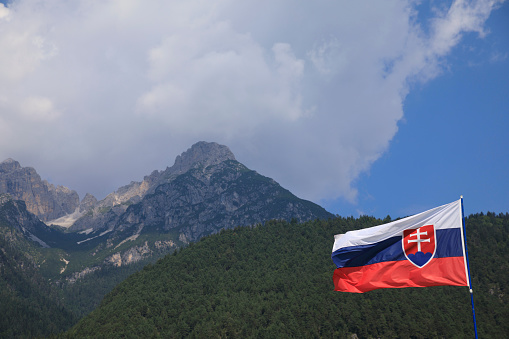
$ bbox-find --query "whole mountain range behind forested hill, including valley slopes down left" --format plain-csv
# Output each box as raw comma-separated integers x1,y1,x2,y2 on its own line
0,142,333,332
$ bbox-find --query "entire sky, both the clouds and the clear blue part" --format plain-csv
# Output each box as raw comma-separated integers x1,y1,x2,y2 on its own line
0,0,509,217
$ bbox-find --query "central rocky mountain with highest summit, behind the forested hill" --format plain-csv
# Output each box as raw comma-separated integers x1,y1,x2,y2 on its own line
55,142,333,274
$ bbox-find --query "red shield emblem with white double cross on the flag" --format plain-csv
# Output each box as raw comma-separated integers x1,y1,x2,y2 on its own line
403,225,437,267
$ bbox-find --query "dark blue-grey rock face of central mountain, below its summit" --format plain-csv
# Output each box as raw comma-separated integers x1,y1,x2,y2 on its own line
112,160,332,241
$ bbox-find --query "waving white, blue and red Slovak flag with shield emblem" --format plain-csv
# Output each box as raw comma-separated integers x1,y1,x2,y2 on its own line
332,199,469,293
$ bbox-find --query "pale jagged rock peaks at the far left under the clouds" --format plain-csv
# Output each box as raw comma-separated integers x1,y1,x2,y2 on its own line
0,158,79,221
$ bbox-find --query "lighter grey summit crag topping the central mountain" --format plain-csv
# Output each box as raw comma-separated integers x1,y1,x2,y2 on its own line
172,141,235,173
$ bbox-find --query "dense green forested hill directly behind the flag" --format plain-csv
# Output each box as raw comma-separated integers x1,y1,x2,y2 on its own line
66,213,509,338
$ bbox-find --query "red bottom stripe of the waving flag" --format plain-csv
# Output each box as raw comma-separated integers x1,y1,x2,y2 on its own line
333,257,468,293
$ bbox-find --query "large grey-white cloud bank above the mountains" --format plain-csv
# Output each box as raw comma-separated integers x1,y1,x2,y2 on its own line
0,0,499,202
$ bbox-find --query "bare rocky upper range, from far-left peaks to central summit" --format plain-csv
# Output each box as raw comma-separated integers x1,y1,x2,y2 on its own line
0,141,333,265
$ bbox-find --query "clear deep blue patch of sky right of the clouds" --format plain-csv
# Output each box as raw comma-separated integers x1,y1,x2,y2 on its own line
325,3,509,217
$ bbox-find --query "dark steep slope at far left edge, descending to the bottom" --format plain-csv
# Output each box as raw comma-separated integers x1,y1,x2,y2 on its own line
0,196,77,338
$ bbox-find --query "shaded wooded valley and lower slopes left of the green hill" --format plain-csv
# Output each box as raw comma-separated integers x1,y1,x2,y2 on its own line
0,218,157,338
